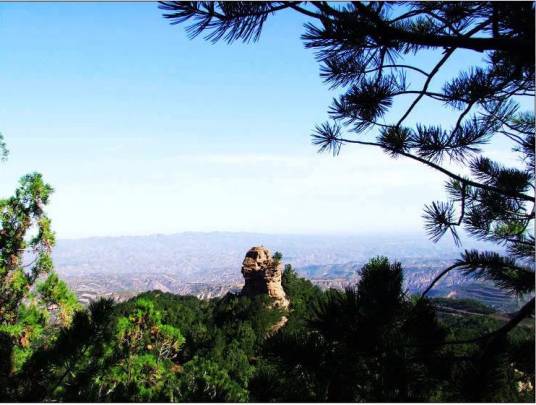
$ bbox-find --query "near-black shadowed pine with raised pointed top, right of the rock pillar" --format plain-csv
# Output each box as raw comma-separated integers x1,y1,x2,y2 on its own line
252,258,452,402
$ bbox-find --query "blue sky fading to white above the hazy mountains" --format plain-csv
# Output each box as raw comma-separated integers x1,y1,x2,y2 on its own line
0,3,524,238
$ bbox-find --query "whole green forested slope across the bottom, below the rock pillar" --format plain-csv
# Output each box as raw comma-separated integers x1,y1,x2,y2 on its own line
2,258,534,402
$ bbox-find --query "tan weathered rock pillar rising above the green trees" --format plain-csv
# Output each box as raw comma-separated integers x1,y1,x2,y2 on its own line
242,246,289,309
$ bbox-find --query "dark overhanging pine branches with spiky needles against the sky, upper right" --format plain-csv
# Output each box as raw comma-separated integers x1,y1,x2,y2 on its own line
160,1,535,339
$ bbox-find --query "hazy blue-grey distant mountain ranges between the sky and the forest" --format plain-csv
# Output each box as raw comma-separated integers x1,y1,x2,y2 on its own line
53,232,524,308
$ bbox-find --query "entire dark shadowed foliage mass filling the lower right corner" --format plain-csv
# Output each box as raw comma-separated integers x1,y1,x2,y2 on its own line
258,258,534,402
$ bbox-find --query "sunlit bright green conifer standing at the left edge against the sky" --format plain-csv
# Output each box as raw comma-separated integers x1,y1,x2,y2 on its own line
0,173,79,370
